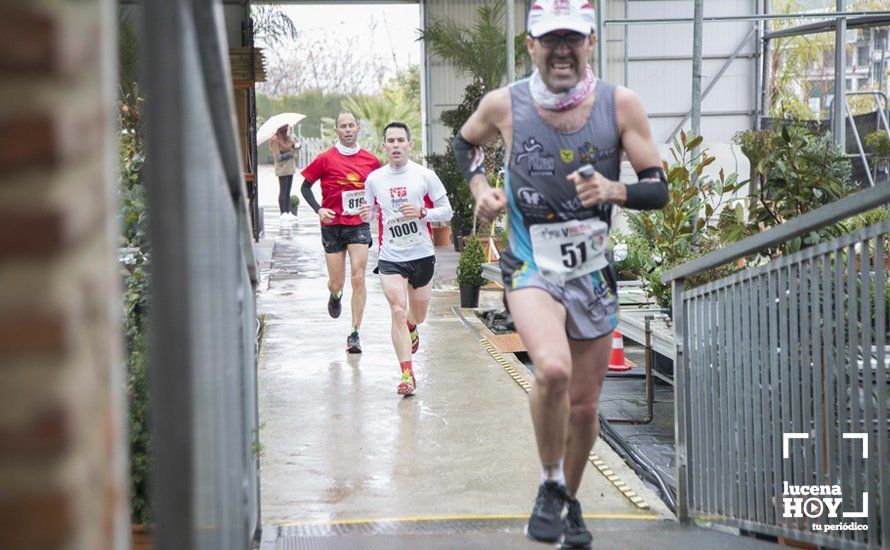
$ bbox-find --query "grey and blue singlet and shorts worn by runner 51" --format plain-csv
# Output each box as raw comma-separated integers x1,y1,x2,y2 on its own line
500,75,621,340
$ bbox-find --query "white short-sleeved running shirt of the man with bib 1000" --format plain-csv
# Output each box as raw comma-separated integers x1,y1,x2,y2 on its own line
365,160,452,262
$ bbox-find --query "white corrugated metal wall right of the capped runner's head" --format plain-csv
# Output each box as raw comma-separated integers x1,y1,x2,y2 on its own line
605,0,756,143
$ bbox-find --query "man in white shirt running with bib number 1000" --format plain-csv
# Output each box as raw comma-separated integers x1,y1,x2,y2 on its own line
360,122,452,395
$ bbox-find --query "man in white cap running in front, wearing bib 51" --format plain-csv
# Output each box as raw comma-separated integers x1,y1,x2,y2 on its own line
454,0,668,548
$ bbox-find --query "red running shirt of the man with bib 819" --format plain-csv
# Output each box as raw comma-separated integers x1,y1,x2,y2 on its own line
300,147,380,225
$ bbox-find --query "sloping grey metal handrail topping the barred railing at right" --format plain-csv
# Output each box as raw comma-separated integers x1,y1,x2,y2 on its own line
661,185,890,283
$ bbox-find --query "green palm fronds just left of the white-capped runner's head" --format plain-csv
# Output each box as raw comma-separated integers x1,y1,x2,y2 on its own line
417,0,527,91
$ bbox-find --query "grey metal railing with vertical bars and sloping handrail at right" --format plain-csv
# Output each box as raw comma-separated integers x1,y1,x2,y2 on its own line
663,186,890,548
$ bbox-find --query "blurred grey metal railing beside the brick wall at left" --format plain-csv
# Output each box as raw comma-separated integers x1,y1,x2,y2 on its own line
142,0,260,550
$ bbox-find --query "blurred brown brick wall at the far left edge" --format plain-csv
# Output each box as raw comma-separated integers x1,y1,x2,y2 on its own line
0,0,129,549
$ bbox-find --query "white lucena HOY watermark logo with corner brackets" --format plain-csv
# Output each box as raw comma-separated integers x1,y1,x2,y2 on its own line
782,433,868,531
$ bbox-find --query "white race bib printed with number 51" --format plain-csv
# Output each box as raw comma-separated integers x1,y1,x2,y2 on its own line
530,220,609,283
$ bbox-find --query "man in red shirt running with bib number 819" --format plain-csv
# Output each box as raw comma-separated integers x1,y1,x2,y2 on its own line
300,112,380,353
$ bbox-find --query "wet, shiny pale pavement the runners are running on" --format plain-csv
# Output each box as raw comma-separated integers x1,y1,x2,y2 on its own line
250,171,772,550
